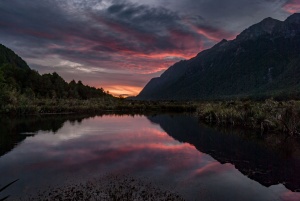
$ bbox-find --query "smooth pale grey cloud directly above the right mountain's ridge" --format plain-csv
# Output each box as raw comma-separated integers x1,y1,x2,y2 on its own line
142,0,292,30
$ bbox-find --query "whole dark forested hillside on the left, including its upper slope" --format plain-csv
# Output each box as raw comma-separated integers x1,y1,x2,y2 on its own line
0,45,112,114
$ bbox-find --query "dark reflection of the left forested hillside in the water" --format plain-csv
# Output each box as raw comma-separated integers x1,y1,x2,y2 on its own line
0,115,95,157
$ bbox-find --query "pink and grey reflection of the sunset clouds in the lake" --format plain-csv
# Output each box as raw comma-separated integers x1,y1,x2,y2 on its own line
0,115,298,200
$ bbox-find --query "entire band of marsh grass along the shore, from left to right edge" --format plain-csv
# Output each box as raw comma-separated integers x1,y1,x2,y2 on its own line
0,95,300,136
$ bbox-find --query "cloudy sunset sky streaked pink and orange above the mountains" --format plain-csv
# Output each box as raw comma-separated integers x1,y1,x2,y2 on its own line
0,0,300,96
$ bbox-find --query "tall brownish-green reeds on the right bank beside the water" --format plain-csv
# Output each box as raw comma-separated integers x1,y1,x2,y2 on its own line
196,99,300,136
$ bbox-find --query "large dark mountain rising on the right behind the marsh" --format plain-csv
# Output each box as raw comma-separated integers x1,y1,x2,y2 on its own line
136,13,300,100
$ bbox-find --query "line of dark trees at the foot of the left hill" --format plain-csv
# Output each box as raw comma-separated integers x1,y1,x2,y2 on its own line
0,63,111,104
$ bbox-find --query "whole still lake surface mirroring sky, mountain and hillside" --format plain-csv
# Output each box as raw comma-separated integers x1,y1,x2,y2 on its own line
0,114,300,201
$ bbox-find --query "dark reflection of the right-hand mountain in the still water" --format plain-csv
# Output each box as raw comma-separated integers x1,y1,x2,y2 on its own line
148,115,300,191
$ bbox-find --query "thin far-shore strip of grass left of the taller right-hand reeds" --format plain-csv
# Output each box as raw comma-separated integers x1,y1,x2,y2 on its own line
0,97,196,115
